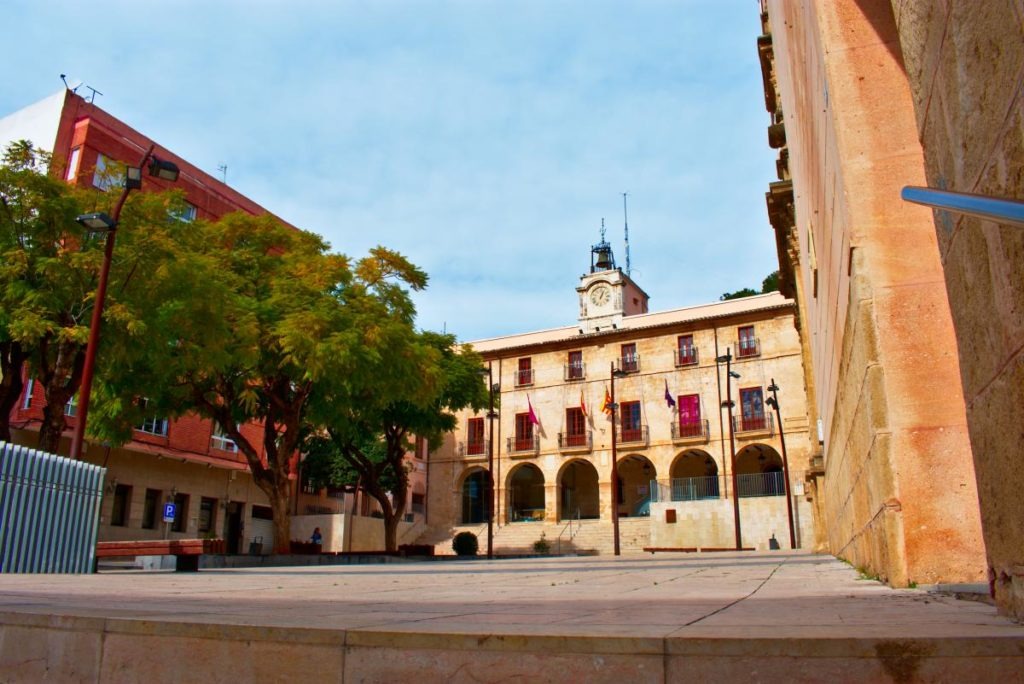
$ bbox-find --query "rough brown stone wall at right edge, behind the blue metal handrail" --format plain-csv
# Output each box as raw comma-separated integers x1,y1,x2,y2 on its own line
892,0,1024,617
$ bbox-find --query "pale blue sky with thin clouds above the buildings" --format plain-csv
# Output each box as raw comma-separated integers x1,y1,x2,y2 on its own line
0,0,777,341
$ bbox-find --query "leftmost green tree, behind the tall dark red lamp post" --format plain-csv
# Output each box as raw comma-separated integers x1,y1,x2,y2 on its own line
0,141,205,452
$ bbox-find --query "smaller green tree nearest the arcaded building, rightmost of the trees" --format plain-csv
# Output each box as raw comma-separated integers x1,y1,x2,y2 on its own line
307,332,487,551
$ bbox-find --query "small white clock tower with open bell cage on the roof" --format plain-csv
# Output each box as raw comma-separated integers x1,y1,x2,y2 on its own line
577,227,647,333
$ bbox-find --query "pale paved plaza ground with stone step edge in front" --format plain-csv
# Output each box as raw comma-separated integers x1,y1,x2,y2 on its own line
0,552,1024,682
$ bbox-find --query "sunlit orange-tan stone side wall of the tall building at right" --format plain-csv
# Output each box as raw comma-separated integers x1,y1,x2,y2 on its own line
758,0,985,586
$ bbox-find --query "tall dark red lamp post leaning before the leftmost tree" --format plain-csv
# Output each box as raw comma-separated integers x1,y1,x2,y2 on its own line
71,144,178,461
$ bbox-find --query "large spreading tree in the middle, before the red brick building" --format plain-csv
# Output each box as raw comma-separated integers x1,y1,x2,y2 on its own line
117,213,426,553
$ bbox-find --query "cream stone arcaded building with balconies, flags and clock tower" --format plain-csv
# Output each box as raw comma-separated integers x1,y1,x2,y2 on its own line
428,248,815,550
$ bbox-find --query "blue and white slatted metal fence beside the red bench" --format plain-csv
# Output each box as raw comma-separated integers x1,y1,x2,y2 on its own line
0,441,106,572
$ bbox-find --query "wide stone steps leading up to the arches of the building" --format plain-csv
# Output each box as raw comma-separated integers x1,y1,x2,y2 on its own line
416,517,650,556
